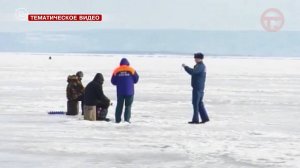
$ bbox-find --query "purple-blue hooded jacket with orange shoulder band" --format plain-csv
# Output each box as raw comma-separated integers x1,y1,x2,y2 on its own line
111,58,139,96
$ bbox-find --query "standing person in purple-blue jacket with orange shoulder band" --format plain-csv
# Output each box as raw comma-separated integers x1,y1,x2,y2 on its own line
111,58,139,123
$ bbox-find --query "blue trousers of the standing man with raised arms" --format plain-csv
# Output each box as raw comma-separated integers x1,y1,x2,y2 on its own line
192,89,209,122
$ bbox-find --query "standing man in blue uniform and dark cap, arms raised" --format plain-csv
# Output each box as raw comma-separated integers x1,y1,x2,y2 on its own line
182,53,209,124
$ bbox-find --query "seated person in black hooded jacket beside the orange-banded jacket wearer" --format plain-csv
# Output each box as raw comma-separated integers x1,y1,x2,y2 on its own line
84,73,110,121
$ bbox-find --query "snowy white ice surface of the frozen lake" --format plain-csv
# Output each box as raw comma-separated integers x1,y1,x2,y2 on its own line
0,53,300,168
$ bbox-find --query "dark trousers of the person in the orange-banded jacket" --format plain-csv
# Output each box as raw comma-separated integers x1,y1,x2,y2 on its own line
115,95,133,123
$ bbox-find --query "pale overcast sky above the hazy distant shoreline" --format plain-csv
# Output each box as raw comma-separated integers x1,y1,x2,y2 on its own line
0,0,300,32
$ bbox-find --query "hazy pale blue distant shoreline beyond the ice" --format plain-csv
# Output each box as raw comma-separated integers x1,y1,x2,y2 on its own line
0,30,300,57
